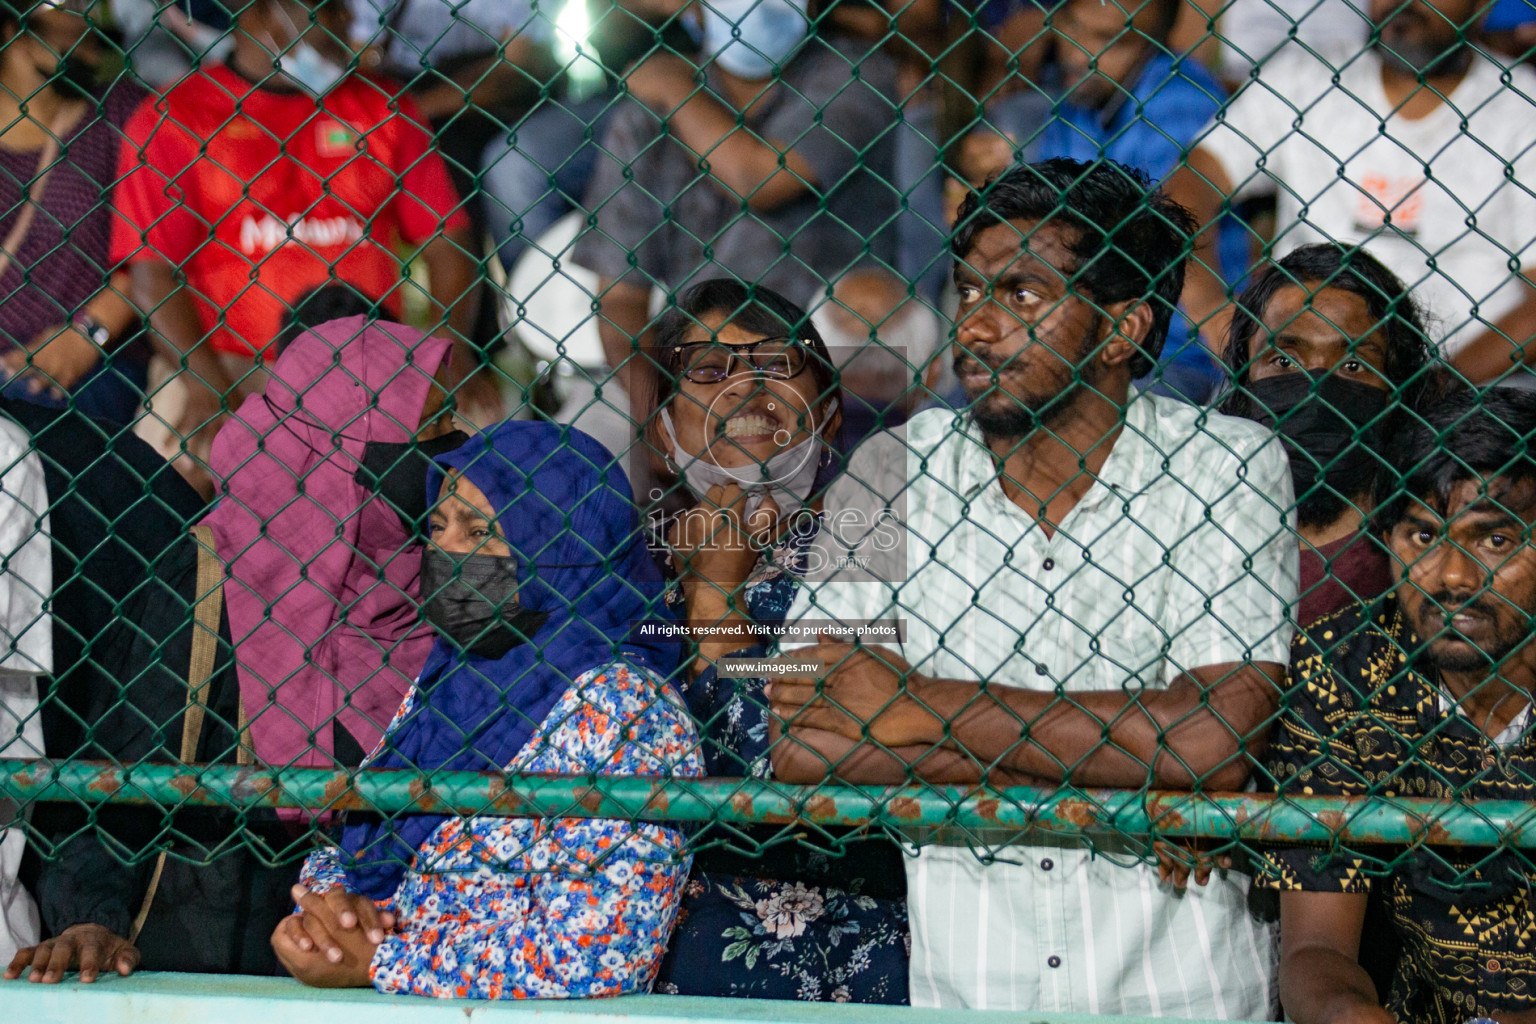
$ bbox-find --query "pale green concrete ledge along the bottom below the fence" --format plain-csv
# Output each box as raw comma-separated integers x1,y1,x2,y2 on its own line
0,972,1222,1024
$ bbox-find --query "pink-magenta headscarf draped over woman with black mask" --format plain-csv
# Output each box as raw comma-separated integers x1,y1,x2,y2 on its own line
203,316,449,766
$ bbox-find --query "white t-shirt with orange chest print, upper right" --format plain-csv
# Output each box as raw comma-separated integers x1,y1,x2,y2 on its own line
1198,52,1536,355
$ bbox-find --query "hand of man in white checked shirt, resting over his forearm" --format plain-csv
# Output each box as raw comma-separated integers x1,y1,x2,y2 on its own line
765,634,946,748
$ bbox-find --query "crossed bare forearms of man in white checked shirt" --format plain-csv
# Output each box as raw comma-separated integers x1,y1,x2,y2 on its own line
768,642,1284,791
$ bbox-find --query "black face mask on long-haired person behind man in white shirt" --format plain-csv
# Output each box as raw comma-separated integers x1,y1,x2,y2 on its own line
1247,370,1390,511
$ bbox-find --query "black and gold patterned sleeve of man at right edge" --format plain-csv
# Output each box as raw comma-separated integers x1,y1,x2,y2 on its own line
1255,619,1372,894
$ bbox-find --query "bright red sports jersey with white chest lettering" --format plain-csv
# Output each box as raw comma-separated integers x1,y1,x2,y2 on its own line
112,66,468,355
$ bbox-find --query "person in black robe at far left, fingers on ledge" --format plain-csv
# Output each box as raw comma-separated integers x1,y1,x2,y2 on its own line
0,399,294,981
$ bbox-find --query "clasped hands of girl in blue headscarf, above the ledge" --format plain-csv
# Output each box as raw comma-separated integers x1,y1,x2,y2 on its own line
272,886,384,989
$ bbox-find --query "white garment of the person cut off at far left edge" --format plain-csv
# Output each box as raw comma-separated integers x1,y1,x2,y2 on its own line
0,418,54,964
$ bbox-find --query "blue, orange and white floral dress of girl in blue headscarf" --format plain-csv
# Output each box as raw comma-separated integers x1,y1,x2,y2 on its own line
301,663,703,999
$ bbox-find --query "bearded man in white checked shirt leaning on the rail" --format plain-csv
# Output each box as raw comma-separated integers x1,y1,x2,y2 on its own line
770,160,1296,1019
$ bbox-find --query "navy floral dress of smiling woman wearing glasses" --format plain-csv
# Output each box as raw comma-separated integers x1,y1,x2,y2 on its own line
656,517,911,1004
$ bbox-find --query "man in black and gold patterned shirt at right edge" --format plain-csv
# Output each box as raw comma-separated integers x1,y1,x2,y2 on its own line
1260,388,1536,1024
